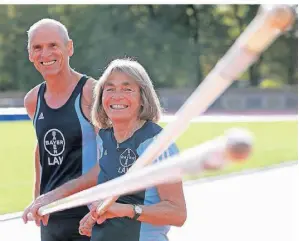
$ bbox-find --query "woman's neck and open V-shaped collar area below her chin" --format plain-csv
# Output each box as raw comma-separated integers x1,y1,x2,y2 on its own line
113,119,145,143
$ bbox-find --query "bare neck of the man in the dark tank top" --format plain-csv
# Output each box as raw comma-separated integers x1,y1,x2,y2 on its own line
44,69,79,94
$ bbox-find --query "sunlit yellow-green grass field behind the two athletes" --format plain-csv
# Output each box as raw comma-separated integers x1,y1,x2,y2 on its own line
0,121,298,214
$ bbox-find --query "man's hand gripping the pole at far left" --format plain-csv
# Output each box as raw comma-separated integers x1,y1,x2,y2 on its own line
22,196,49,227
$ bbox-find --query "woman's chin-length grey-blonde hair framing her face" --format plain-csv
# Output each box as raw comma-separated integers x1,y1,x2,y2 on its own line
91,59,162,129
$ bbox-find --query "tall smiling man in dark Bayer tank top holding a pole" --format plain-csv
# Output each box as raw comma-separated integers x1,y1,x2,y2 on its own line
23,19,99,241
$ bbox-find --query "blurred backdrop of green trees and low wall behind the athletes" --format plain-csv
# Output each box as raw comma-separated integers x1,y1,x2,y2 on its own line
0,5,298,113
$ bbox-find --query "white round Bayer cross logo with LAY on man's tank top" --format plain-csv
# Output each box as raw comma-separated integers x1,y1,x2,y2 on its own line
44,129,65,166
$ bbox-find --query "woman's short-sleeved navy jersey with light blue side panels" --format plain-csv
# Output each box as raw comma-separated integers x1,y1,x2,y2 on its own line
92,121,178,241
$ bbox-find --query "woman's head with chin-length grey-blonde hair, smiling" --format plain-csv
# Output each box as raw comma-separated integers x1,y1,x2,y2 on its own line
91,59,161,128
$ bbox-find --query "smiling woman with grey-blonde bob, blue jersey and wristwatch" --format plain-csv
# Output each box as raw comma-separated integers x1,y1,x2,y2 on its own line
80,59,187,241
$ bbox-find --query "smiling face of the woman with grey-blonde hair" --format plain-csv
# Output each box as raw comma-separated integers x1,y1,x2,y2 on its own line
102,72,141,123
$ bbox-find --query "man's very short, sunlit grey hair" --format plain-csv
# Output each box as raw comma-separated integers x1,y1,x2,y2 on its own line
27,18,70,49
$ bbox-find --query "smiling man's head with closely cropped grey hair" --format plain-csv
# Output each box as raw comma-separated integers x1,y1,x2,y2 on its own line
28,19,74,78
